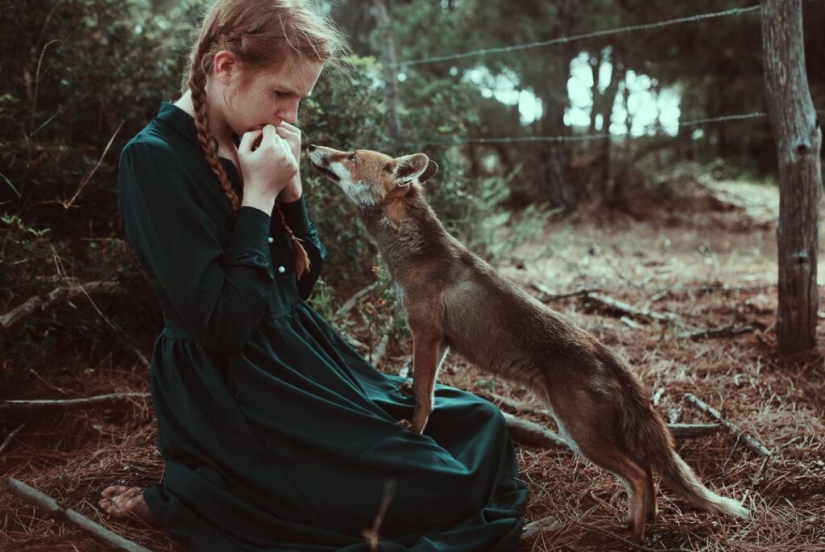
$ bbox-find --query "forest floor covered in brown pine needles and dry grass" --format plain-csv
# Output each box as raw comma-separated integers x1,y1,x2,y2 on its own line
0,170,825,552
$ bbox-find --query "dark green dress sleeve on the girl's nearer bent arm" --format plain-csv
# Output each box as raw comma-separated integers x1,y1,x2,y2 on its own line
118,139,274,354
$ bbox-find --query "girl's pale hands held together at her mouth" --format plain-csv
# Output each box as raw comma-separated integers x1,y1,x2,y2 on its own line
238,125,300,214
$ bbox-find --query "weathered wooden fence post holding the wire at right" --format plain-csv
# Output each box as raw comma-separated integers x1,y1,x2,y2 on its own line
762,0,822,355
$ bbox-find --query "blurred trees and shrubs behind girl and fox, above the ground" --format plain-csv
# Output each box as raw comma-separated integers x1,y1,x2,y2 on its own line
0,0,825,376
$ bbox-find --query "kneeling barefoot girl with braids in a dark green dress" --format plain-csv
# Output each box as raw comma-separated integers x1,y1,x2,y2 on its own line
100,0,526,552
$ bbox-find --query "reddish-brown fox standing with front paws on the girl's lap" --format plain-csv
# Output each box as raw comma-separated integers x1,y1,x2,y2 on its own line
308,144,749,542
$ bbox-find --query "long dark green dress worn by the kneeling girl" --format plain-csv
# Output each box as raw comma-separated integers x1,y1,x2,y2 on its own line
119,103,526,552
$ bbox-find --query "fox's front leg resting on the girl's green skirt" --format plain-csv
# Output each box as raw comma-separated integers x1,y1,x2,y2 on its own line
410,332,448,435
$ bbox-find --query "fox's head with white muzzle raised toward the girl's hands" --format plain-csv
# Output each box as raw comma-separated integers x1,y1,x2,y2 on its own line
309,145,438,213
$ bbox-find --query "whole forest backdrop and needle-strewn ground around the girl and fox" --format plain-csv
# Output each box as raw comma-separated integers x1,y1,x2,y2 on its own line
0,0,825,552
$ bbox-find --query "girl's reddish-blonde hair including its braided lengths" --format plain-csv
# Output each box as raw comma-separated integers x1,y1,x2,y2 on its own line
182,0,346,277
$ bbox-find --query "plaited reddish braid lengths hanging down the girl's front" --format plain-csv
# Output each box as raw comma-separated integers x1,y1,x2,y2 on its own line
189,38,310,278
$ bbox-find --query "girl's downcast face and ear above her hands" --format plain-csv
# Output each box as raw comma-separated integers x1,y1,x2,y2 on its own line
210,54,323,136
